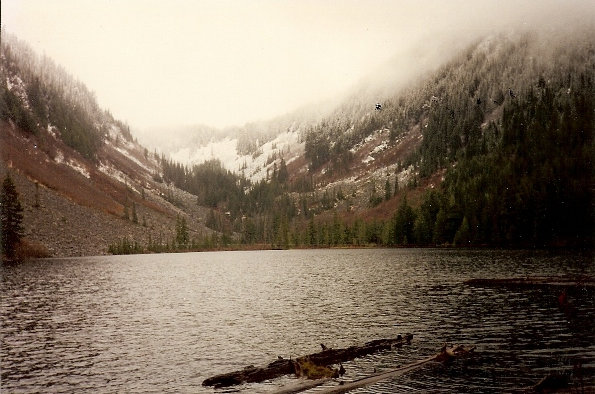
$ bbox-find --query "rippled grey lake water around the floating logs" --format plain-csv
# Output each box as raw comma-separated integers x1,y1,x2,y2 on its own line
0,249,595,393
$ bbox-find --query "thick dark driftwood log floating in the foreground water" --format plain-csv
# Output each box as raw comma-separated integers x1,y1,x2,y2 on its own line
202,334,413,387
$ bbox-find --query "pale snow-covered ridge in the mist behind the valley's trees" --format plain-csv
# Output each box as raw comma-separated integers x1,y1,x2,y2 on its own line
158,37,471,181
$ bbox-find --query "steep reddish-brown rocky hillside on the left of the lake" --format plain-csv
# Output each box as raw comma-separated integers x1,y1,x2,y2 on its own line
0,32,211,256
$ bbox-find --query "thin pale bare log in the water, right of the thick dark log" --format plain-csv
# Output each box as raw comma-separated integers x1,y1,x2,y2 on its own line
276,345,475,394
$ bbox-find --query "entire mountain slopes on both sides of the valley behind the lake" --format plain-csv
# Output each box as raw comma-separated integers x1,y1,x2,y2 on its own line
0,28,595,256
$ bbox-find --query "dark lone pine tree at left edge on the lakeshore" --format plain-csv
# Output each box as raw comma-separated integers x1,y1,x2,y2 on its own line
0,174,23,260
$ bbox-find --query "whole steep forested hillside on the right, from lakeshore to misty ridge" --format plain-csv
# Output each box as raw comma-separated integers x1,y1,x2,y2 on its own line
158,28,595,247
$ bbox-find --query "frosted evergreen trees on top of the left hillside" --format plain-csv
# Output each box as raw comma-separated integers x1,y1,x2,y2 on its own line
0,31,132,160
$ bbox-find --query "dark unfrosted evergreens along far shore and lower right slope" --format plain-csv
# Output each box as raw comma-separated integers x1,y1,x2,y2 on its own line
147,67,594,248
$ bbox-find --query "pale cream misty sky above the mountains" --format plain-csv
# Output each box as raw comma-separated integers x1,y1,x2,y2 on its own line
1,0,595,129
